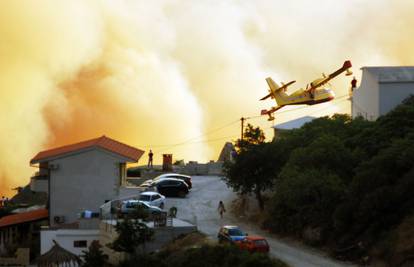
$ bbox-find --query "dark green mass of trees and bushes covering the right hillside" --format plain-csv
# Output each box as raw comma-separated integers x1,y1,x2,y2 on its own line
226,97,414,265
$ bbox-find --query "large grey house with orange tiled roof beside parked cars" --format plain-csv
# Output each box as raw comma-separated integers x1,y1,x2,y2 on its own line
30,136,144,226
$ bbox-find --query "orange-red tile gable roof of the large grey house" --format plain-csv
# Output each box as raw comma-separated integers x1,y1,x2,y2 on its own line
30,135,144,164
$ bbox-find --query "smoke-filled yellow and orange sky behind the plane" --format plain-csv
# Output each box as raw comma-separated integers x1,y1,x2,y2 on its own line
0,0,414,197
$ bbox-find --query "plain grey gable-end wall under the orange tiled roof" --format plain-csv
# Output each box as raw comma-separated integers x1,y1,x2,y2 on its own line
49,148,126,225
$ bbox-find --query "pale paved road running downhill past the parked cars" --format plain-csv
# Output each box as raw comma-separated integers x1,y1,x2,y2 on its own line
165,176,354,267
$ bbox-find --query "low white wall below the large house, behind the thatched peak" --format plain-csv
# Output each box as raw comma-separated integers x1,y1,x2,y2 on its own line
40,229,99,256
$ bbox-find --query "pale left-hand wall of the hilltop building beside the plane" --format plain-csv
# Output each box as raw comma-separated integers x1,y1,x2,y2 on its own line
352,69,379,120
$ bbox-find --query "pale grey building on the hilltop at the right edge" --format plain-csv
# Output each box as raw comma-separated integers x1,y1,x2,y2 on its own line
351,66,414,120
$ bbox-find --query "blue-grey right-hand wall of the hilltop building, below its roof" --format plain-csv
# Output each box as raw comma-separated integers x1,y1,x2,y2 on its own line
379,82,414,115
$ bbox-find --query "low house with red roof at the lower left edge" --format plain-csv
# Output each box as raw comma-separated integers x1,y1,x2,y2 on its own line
0,209,48,255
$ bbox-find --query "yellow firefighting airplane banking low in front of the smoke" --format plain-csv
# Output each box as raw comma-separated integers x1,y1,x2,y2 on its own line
260,60,352,121
